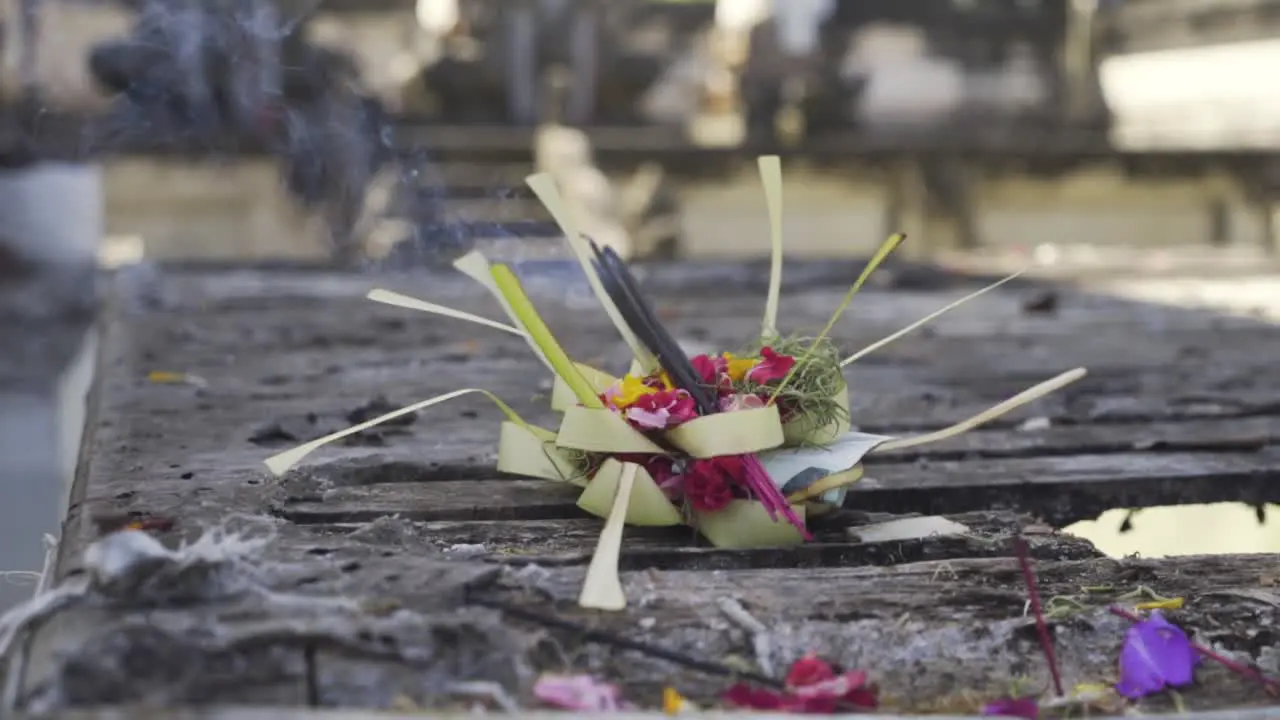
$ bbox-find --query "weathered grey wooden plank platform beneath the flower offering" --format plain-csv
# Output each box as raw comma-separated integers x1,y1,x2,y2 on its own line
10,264,1280,714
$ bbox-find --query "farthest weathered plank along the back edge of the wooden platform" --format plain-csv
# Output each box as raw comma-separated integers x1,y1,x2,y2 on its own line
122,261,1267,342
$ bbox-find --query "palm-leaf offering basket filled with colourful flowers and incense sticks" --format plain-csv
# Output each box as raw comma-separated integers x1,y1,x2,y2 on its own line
266,156,1084,610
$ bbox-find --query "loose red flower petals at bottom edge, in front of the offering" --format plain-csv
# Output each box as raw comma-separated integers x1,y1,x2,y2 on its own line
723,655,879,715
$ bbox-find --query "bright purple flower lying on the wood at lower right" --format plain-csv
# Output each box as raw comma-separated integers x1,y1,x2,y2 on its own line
1116,611,1196,698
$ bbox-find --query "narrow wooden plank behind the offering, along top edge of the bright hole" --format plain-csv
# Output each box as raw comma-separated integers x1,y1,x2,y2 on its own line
279,452,1280,524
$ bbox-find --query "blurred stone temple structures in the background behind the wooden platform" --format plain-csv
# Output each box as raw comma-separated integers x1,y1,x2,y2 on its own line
0,0,1280,605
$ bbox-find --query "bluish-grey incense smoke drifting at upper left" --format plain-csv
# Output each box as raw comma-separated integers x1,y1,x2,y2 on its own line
88,0,419,265
